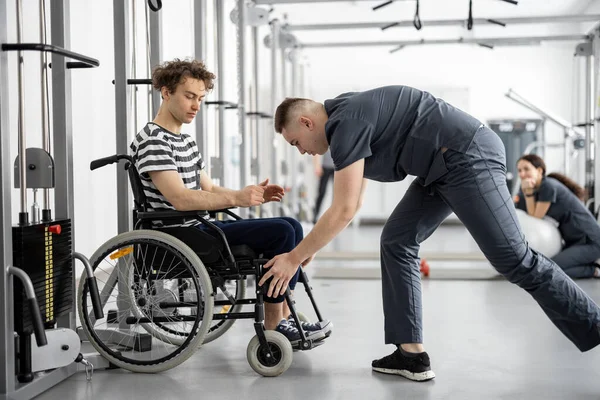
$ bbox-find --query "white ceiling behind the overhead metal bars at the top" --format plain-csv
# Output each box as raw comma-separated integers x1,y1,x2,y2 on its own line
257,0,600,43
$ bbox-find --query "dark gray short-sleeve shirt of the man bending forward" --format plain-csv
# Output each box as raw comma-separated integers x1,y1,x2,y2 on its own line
325,86,481,185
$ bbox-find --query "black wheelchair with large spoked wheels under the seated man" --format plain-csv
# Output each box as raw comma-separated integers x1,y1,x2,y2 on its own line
77,155,330,376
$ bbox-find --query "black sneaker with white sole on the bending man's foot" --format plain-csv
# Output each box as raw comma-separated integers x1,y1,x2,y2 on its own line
371,349,435,382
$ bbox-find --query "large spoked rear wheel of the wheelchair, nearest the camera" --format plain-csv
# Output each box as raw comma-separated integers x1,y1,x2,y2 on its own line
77,230,213,373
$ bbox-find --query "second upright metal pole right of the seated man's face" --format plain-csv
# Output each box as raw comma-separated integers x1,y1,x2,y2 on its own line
236,0,250,191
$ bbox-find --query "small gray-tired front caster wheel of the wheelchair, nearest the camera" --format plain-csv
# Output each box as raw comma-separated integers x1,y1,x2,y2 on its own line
246,331,293,376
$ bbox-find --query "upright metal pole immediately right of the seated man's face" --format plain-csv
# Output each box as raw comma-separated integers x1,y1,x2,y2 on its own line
213,0,228,187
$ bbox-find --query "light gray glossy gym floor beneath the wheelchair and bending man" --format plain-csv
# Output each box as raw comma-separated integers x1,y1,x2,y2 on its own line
37,228,600,400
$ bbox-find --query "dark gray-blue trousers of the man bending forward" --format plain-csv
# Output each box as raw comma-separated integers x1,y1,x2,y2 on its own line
381,128,600,351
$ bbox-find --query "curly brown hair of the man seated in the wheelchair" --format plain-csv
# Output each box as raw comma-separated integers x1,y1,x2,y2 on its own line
152,58,216,93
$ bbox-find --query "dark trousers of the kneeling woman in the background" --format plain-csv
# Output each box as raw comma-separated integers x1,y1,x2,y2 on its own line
552,244,600,279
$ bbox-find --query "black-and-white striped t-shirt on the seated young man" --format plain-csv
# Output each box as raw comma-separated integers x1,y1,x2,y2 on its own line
130,122,204,211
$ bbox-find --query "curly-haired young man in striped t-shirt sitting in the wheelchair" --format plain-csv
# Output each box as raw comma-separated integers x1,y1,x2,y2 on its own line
130,60,332,344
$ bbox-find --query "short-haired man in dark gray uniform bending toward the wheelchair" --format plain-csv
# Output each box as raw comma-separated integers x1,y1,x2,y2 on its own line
259,86,600,381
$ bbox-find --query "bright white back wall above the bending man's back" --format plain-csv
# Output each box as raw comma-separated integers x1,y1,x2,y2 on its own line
306,44,574,219
